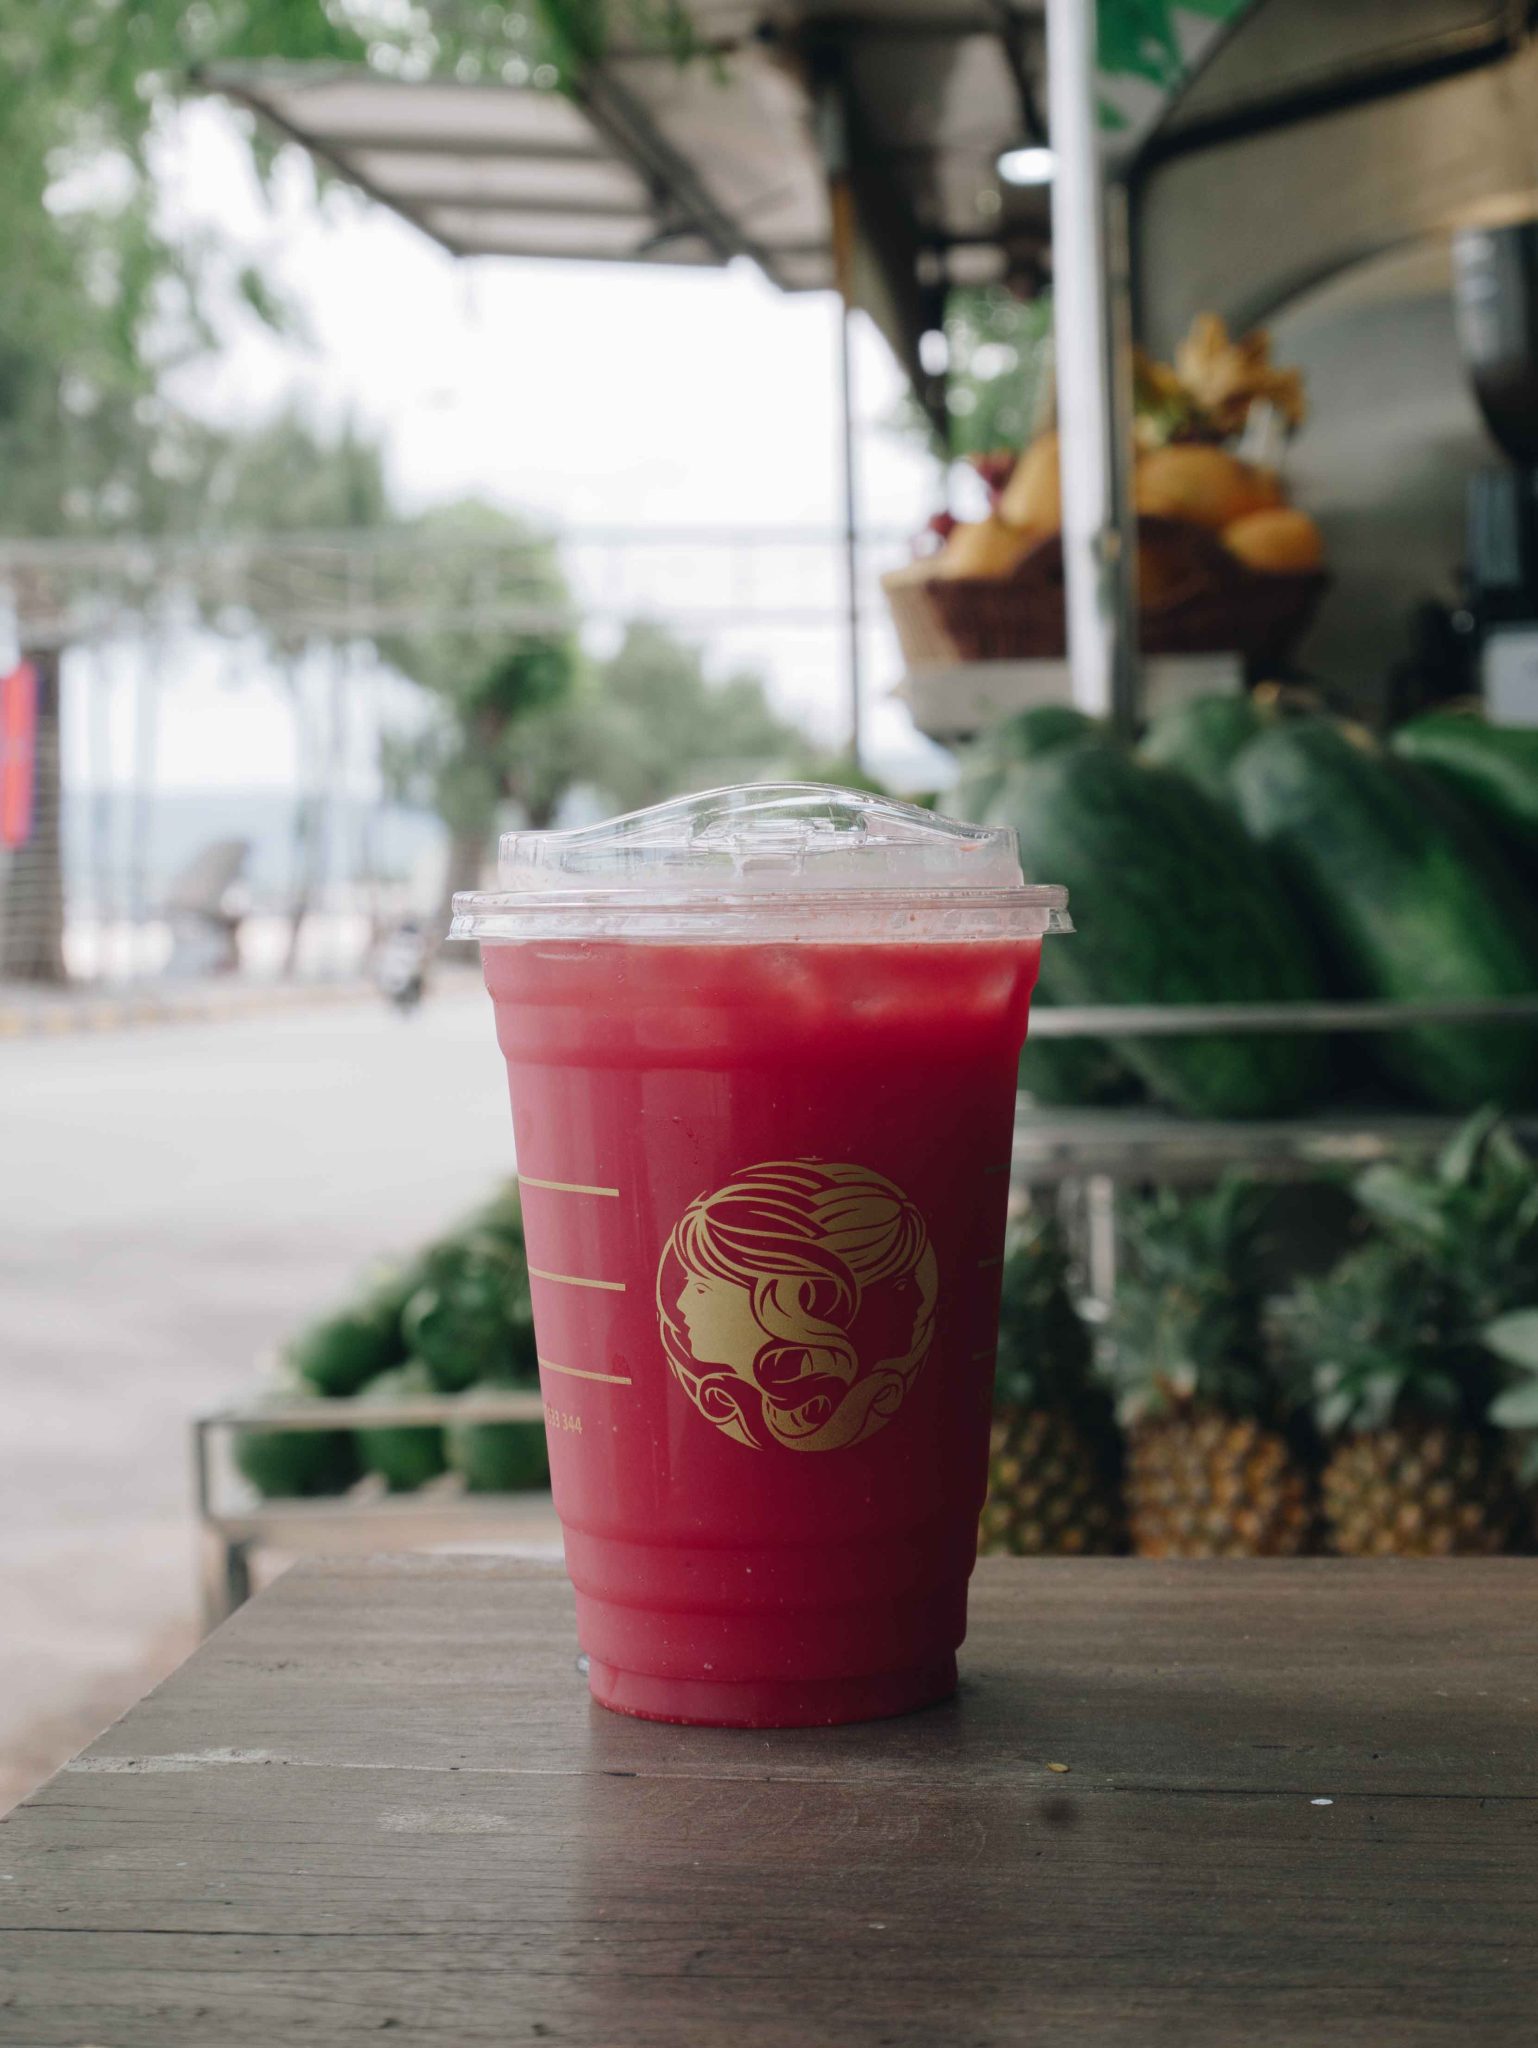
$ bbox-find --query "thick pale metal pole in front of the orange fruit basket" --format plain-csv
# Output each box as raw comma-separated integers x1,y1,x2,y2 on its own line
1046,0,1137,733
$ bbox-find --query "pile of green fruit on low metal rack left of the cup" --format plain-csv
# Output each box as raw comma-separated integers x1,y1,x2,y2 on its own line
233,1186,549,1497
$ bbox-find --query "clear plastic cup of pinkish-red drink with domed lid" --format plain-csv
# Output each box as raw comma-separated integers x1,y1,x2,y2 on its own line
453,784,1071,1726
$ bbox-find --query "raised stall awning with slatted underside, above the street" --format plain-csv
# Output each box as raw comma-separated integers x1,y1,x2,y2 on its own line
203,0,1243,401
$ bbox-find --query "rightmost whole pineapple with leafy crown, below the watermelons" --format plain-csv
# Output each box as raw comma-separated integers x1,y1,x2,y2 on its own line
1280,1243,1515,1556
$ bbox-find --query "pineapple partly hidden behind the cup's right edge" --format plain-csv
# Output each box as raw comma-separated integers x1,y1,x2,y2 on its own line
977,1217,1122,1556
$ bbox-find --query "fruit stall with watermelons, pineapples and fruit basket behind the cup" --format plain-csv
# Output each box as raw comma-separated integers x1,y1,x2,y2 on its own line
199,0,1538,1581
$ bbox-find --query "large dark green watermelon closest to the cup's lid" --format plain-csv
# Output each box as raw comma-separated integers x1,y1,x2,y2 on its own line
991,741,1327,1116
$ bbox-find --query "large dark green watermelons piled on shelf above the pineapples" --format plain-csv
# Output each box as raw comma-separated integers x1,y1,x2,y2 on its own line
966,698,1538,1118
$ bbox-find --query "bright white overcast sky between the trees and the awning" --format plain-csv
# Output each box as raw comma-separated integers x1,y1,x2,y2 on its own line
66,100,962,788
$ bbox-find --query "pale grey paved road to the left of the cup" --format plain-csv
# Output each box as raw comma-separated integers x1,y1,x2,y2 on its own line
0,977,512,1810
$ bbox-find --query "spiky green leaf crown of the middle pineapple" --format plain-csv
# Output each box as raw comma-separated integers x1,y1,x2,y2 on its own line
1106,1174,1274,1421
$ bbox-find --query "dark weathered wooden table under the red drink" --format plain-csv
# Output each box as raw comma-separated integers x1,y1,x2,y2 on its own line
0,1559,1538,2048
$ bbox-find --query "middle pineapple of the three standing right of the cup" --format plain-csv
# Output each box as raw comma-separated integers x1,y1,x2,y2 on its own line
1106,1178,1313,1556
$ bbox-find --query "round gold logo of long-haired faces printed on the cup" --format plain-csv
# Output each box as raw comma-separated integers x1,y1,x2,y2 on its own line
657,1159,940,1450
